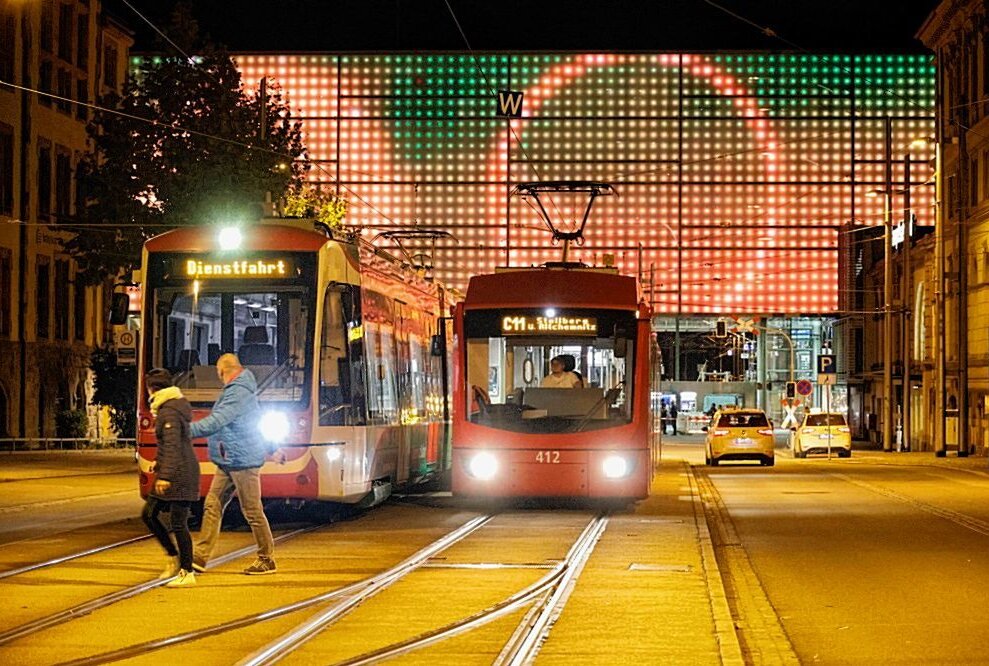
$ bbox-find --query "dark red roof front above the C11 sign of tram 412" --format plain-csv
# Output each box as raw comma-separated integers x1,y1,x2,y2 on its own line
464,268,639,310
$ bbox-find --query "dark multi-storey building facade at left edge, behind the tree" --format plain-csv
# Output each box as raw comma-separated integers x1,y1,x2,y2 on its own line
0,0,133,438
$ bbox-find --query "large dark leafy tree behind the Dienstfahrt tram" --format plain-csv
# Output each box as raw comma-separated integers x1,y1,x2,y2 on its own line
66,6,306,283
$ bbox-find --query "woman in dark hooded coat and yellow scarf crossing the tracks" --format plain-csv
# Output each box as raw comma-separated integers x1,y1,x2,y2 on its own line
141,368,199,587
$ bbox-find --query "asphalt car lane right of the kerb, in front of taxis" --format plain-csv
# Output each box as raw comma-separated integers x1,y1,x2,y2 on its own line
668,436,989,664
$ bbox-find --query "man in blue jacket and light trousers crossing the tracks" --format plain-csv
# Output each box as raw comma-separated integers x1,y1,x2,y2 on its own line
190,354,276,576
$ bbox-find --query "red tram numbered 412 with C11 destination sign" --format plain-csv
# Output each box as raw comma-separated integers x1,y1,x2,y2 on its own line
452,263,656,499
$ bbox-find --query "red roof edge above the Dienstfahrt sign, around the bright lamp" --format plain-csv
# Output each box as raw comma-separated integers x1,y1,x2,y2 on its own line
145,224,330,252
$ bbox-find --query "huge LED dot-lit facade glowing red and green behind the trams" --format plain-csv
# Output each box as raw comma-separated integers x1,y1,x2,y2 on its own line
228,53,934,314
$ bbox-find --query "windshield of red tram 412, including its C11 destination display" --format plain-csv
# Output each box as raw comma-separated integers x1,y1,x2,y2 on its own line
465,310,636,433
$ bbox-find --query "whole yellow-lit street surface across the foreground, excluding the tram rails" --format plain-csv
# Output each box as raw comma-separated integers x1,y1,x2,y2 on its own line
0,438,989,664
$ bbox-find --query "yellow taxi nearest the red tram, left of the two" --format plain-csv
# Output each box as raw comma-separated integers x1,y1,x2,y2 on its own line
704,407,776,467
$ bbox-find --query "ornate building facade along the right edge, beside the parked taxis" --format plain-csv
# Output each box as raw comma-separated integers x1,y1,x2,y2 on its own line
858,0,989,456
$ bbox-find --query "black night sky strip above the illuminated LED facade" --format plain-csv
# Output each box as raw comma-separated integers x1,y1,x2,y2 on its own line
110,0,937,53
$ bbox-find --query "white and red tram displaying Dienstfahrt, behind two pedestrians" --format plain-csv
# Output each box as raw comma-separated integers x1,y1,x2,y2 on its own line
138,220,449,504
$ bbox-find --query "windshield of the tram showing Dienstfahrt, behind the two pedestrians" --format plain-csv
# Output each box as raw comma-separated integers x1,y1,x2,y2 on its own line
147,284,311,404
